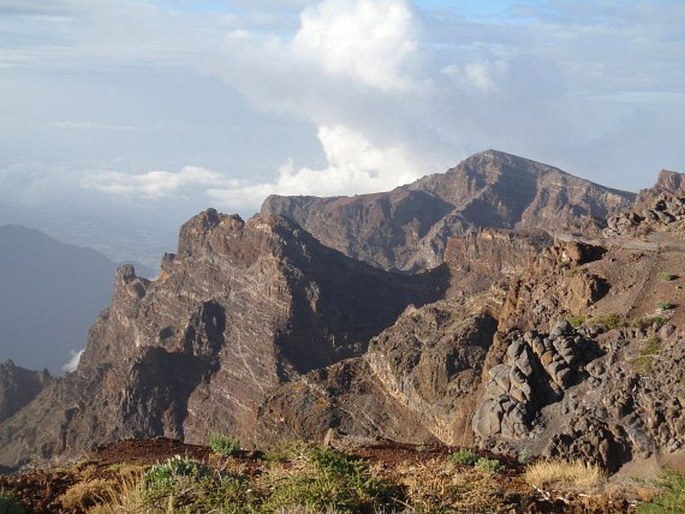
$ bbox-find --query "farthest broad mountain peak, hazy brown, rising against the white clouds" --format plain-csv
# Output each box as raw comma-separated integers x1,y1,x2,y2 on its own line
262,150,635,270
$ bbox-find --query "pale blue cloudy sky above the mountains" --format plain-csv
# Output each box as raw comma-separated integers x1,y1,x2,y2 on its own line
0,0,685,258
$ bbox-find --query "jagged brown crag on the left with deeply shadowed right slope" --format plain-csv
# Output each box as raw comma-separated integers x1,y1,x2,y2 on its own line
0,209,444,466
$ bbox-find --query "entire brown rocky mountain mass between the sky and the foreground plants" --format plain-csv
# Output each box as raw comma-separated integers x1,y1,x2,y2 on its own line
0,151,685,470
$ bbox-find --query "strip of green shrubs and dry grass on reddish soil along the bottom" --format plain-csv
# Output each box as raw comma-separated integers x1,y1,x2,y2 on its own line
0,436,685,514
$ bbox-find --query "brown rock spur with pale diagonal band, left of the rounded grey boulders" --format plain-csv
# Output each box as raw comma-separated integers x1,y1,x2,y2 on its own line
254,293,501,445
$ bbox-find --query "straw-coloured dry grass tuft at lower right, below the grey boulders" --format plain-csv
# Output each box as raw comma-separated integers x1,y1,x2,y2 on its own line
524,460,607,491
